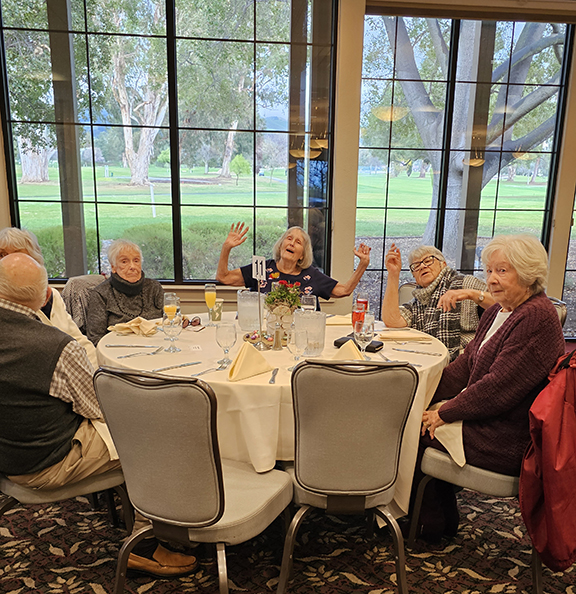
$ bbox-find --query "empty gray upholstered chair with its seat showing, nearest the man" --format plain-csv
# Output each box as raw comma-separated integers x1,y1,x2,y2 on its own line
94,367,292,594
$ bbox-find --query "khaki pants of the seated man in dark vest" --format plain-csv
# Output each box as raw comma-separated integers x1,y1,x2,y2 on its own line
8,419,149,532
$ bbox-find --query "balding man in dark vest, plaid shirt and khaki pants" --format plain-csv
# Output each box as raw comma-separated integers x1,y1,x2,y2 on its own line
0,253,197,577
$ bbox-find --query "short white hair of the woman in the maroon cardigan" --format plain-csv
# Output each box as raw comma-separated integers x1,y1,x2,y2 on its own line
482,234,548,295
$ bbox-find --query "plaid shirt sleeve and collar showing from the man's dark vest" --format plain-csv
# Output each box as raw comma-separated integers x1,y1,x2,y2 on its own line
0,299,102,419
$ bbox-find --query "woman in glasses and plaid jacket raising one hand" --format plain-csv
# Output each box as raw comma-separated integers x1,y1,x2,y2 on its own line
382,244,494,361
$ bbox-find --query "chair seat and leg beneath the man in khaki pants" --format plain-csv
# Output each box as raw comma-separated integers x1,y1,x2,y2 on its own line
0,470,134,533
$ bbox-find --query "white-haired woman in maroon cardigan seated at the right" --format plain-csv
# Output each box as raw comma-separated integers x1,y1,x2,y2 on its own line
415,235,565,540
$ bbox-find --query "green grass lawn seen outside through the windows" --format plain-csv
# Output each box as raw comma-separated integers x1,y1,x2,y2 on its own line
18,166,546,237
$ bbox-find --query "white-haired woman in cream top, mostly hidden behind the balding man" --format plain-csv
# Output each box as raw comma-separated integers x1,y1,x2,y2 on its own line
0,227,98,368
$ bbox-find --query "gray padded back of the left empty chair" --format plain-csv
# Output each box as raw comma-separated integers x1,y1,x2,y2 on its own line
94,367,224,528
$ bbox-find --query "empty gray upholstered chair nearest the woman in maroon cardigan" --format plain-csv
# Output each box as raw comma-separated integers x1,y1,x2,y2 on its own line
278,360,418,593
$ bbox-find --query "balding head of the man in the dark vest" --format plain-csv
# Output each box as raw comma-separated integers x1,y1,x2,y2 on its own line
0,253,48,310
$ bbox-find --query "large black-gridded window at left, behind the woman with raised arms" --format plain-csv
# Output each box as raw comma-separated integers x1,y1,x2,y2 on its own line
0,0,335,282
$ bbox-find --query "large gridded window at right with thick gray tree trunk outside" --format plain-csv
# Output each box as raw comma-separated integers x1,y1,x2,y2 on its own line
356,15,571,314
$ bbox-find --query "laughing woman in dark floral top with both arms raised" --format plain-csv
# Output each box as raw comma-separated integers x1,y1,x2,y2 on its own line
216,223,370,299
